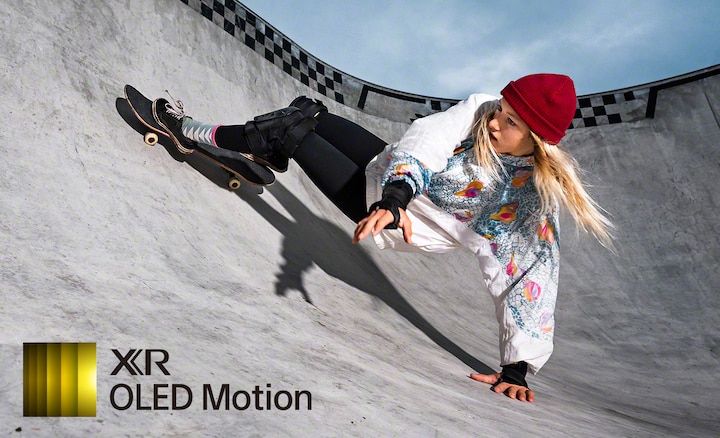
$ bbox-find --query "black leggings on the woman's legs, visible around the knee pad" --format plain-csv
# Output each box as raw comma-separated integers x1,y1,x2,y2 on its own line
215,112,387,223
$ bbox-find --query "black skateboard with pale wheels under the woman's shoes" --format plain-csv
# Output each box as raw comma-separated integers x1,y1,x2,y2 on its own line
124,85,275,190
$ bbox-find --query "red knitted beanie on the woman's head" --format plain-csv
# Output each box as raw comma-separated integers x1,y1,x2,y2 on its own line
500,73,577,144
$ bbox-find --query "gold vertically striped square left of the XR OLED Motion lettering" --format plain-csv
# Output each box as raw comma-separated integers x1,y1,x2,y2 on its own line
23,342,97,417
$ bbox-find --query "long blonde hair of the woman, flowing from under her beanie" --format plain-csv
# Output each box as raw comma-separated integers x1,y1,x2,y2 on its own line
473,109,613,249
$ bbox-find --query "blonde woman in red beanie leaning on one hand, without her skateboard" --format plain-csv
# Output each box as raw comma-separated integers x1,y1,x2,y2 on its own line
155,74,611,401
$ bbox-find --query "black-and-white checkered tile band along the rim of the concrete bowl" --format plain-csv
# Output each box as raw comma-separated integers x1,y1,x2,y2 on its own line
180,0,720,129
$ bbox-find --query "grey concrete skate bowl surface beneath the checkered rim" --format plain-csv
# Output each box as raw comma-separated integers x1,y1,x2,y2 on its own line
0,0,720,437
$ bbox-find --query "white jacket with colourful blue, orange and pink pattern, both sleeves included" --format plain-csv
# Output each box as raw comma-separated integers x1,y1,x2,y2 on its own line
366,95,559,373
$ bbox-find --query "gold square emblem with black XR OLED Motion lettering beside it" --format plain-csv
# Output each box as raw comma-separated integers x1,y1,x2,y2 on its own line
23,342,312,417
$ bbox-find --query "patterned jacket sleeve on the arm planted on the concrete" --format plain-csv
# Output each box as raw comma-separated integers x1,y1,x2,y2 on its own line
485,209,560,374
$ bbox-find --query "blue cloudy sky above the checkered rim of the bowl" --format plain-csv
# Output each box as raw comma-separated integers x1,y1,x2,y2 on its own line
241,0,720,99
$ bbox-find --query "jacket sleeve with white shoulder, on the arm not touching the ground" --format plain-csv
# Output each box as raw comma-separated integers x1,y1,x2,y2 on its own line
382,94,496,197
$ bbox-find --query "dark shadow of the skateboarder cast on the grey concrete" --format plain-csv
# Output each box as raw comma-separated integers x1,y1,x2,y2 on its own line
237,181,495,373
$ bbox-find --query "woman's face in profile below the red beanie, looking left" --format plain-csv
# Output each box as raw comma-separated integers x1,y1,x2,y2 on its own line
488,99,535,157
